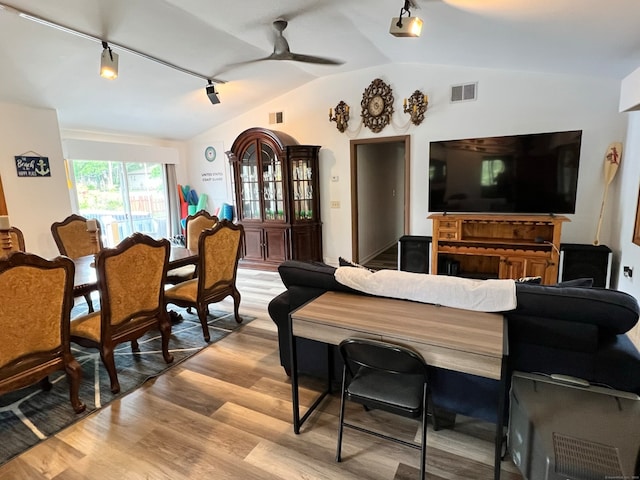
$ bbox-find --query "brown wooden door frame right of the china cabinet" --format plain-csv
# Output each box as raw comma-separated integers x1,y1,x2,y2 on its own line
350,135,411,262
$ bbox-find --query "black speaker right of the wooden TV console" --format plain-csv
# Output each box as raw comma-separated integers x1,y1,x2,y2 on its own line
558,243,613,288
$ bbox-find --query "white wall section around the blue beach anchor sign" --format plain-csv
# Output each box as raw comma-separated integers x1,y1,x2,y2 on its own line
0,103,71,258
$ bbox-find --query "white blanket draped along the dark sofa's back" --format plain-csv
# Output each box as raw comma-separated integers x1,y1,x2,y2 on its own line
335,267,516,312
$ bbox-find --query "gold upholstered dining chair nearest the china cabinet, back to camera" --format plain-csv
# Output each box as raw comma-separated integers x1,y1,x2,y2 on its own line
165,220,244,342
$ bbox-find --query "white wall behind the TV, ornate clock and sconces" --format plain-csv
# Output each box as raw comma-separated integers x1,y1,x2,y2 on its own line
189,64,627,263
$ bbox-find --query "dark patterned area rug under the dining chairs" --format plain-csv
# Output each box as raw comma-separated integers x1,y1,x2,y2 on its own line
0,305,253,465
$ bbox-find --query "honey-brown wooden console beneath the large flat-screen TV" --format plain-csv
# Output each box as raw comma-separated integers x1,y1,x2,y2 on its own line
428,214,570,284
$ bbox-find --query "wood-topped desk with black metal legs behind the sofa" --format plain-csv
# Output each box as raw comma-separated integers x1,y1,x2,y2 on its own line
289,292,508,479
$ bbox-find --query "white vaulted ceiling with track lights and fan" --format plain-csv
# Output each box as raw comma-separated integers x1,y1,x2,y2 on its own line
0,0,640,139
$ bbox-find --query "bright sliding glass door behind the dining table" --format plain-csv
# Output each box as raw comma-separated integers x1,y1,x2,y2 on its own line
71,160,169,246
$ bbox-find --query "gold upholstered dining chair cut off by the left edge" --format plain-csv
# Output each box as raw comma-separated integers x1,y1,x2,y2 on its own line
0,252,85,413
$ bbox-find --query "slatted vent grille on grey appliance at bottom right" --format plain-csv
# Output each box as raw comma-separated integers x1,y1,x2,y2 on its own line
553,432,623,480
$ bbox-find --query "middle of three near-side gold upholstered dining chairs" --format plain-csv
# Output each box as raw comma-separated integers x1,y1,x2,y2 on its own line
71,232,173,393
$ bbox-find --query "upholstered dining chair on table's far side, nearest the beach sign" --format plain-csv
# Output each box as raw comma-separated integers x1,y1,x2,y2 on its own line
51,213,102,312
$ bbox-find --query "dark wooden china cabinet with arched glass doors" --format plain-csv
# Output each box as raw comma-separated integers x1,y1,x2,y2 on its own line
228,128,322,270
